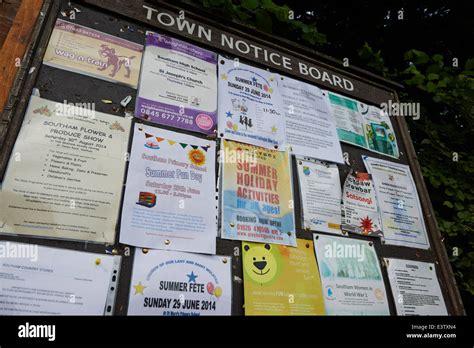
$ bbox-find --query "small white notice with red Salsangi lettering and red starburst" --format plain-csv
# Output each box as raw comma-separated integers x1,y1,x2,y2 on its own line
342,171,383,237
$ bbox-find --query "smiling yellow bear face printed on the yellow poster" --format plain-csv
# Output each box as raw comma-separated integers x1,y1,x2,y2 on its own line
243,243,278,284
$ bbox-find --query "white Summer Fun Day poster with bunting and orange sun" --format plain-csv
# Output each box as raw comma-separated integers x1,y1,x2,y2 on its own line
120,124,217,254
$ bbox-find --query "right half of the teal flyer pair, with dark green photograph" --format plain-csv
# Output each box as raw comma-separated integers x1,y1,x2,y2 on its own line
359,103,400,158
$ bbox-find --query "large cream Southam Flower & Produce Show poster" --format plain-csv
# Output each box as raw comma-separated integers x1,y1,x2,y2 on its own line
0,96,130,243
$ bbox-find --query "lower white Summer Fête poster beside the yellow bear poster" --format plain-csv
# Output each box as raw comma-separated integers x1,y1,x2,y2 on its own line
128,249,232,316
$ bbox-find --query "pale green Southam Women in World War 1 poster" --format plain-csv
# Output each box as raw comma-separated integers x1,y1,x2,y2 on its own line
313,233,390,315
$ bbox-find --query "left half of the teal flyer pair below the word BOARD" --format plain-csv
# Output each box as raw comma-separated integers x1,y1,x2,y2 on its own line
325,91,367,148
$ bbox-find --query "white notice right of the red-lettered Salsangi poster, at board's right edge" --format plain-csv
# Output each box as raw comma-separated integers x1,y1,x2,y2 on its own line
362,156,429,249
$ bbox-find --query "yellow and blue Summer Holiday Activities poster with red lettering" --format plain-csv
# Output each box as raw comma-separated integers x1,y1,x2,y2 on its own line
221,140,296,246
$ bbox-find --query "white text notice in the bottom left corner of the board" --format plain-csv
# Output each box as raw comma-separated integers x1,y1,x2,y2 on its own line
0,242,120,316
